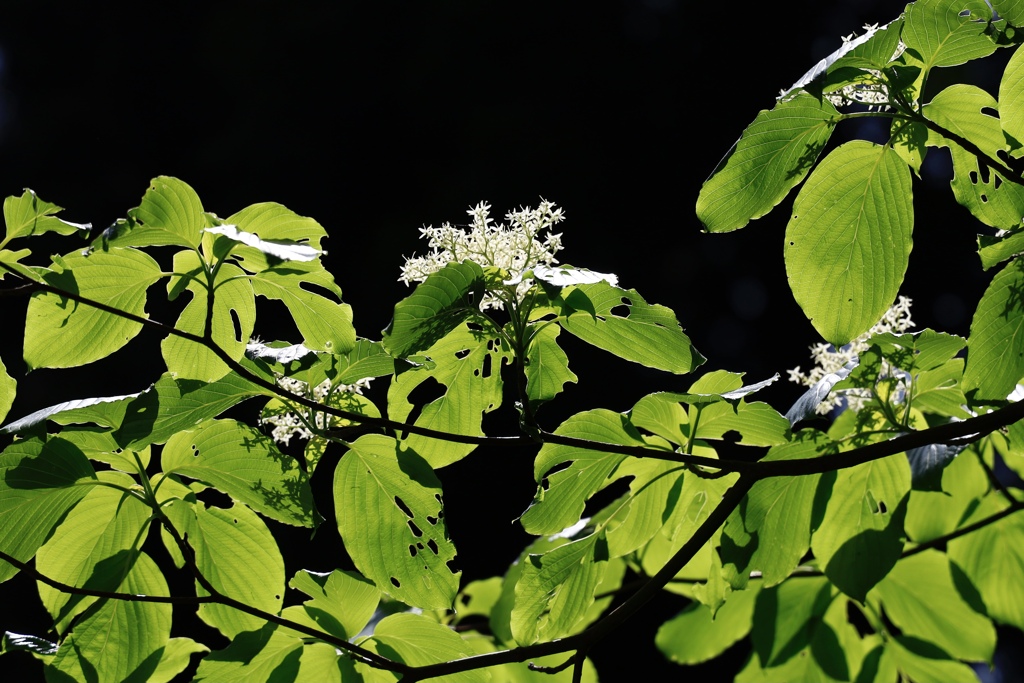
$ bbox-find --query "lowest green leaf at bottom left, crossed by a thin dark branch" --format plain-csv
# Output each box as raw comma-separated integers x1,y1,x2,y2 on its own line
46,554,171,683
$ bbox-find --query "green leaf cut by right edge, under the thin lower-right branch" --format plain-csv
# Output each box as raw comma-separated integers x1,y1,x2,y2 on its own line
948,500,1024,629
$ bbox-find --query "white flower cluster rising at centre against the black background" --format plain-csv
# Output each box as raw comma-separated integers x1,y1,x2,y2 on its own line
398,200,565,309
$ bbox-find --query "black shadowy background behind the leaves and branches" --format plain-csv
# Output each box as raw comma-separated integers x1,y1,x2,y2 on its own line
0,0,1001,681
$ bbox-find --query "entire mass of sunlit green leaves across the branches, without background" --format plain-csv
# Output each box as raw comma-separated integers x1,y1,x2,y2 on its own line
0,0,1024,682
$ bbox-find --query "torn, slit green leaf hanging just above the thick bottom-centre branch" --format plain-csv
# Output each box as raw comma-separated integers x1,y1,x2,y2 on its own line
512,533,606,645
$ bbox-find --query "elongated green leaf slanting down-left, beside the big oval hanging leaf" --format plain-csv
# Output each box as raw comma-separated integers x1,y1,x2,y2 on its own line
697,92,839,232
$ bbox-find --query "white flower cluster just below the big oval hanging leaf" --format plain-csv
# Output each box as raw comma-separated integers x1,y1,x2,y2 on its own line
788,296,913,415
